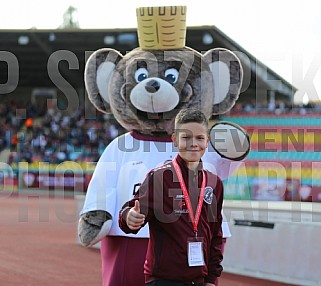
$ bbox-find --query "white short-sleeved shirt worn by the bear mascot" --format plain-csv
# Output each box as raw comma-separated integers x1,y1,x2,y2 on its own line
82,132,236,238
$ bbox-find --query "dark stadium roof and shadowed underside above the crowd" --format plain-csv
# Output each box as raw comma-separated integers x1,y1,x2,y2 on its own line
0,26,296,102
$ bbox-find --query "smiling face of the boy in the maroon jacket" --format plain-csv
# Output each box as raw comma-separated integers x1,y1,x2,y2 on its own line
172,122,209,162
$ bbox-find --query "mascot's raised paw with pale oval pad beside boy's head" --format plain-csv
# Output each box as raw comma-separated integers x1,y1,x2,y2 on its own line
210,121,251,161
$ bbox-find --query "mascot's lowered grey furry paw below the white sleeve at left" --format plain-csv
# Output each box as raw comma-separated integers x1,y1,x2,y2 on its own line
78,210,112,246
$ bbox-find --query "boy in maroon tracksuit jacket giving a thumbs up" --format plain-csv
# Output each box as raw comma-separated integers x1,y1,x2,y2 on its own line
119,109,223,286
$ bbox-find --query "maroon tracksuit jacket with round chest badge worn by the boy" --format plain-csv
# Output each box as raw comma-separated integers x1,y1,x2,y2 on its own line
119,155,223,283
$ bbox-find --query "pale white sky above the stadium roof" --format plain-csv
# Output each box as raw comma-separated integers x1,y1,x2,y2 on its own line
0,0,321,102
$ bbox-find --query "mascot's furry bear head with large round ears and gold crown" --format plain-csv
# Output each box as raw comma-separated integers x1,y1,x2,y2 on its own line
85,6,243,136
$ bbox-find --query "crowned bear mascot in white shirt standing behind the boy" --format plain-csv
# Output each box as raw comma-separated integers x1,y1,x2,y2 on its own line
78,6,250,286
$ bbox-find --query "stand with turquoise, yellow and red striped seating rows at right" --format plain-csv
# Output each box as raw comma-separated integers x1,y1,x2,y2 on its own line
221,113,321,202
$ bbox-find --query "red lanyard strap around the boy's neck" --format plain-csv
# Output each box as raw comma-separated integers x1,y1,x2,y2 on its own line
172,158,206,236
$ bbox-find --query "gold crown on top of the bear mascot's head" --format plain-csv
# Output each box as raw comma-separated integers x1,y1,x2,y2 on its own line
136,6,186,50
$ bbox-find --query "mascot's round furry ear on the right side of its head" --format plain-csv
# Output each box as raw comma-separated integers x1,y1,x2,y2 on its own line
203,48,243,114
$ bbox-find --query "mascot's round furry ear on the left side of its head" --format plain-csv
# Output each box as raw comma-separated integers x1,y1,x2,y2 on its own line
85,48,123,113
